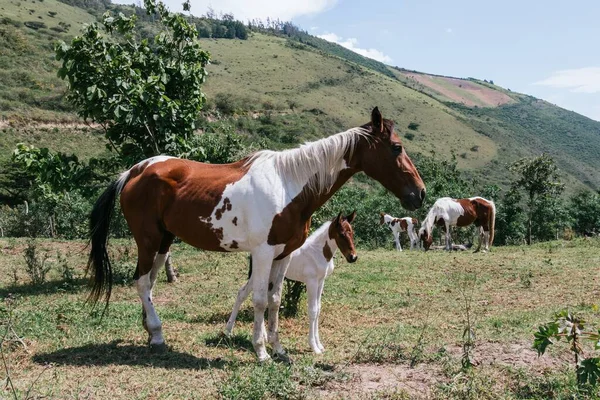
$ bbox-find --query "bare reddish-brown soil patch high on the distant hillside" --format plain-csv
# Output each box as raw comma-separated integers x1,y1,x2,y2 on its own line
405,73,514,107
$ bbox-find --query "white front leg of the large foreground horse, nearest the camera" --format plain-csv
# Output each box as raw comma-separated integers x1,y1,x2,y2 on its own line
252,244,275,362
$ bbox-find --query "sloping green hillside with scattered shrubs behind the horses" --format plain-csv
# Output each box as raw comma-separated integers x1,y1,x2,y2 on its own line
0,0,600,189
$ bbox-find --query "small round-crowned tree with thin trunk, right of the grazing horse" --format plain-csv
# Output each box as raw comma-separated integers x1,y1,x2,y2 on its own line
510,154,564,244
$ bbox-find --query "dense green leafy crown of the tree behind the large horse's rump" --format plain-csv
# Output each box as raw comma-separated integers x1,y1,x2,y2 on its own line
55,0,210,164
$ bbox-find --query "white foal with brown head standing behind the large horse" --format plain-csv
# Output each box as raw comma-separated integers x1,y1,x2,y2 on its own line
225,211,358,354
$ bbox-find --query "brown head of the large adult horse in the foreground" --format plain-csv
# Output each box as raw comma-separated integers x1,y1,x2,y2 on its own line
356,107,425,211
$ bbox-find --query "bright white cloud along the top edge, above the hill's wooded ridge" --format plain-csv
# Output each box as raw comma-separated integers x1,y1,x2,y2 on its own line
115,0,338,21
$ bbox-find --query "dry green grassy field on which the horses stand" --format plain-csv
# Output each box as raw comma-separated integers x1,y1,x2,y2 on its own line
0,239,600,399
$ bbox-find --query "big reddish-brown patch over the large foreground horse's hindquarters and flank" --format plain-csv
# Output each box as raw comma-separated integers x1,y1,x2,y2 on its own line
120,159,248,275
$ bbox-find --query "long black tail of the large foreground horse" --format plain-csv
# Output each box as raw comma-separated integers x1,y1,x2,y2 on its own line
87,181,118,311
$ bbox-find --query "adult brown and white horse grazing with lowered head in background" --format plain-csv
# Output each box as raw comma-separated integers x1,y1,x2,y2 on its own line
419,197,496,252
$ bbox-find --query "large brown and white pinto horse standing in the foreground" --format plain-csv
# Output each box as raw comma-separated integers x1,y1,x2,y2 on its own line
88,108,425,361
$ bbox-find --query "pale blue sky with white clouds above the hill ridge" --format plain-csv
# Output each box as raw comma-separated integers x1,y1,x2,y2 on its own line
126,0,600,120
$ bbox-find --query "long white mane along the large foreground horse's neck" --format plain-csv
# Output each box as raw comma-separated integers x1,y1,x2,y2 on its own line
246,128,369,193
